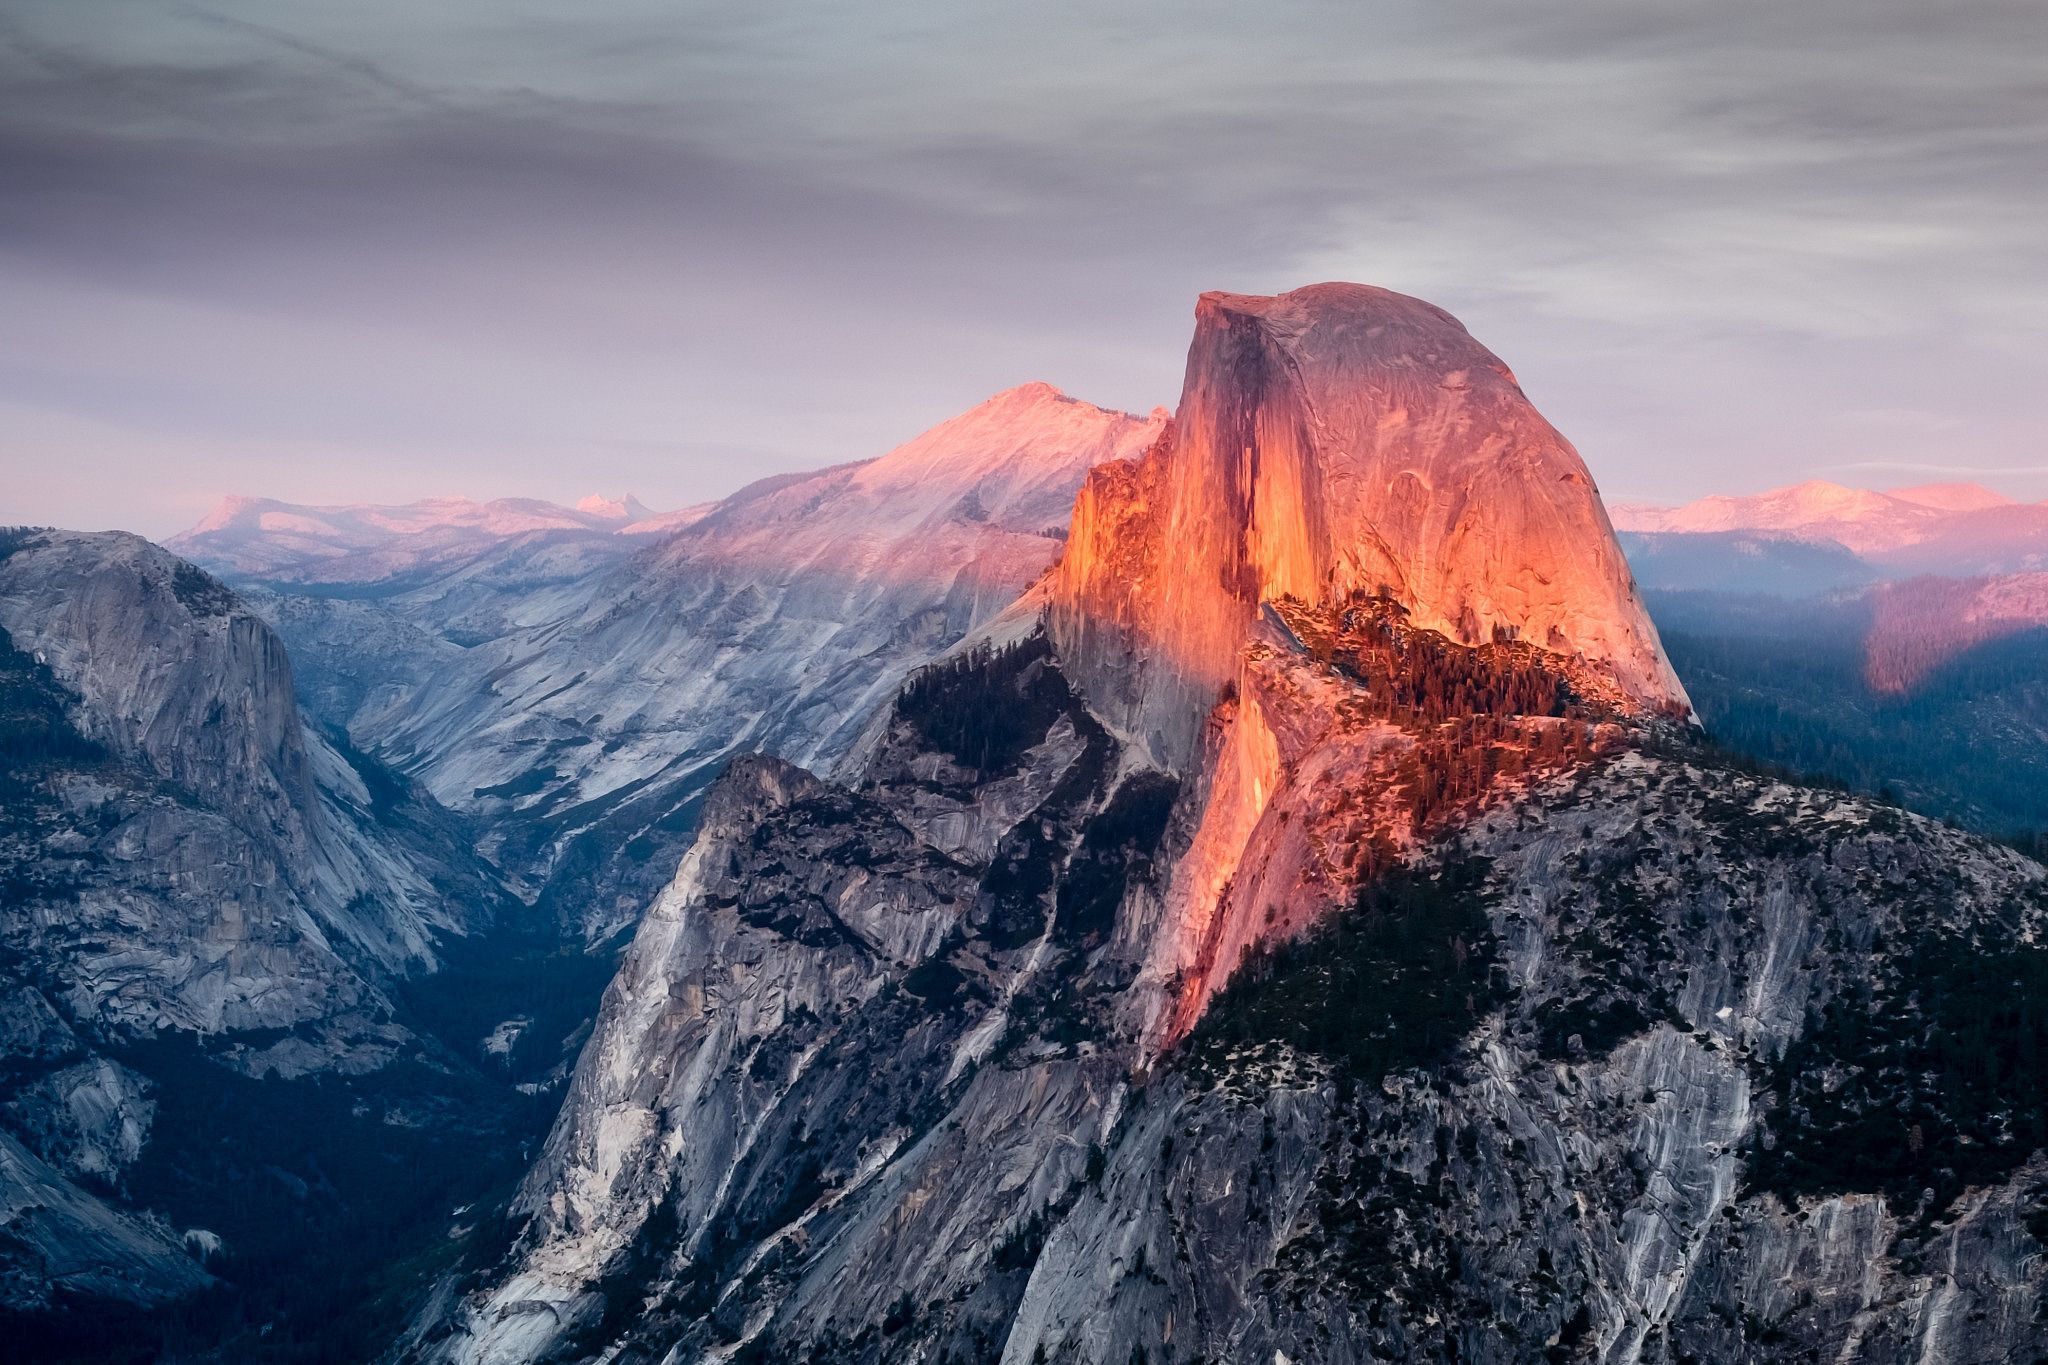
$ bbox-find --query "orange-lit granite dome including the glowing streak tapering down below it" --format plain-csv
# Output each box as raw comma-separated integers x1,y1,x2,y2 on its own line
1049,284,1690,1046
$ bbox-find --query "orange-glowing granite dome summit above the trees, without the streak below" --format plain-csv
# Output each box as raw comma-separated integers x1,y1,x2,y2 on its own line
1049,284,1690,769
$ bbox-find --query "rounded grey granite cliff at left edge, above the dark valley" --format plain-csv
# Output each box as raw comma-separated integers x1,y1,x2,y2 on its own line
0,532,494,1047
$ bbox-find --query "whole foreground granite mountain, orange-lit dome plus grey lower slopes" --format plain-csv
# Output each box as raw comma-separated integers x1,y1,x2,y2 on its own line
397,287,2048,1365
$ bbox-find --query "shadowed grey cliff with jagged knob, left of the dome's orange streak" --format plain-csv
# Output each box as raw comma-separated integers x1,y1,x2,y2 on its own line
397,639,1138,1361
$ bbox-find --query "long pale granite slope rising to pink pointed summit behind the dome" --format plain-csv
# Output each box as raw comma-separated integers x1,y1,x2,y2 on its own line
348,385,1161,939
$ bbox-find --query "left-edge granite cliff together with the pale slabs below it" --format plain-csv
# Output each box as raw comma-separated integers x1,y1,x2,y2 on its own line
0,530,508,1308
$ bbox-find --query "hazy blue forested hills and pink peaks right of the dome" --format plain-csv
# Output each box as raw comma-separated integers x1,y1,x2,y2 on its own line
1610,483,2048,837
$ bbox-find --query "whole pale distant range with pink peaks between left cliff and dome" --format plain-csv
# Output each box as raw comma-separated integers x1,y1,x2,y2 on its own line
172,383,1163,939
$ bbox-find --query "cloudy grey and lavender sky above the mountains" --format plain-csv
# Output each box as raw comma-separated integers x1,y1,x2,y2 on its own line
0,0,2048,538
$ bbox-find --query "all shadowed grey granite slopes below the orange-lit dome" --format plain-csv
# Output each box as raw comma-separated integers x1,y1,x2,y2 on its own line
399,642,2048,1365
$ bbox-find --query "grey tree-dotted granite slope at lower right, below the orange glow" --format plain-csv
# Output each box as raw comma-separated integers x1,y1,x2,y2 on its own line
1024,755,2048,1361
